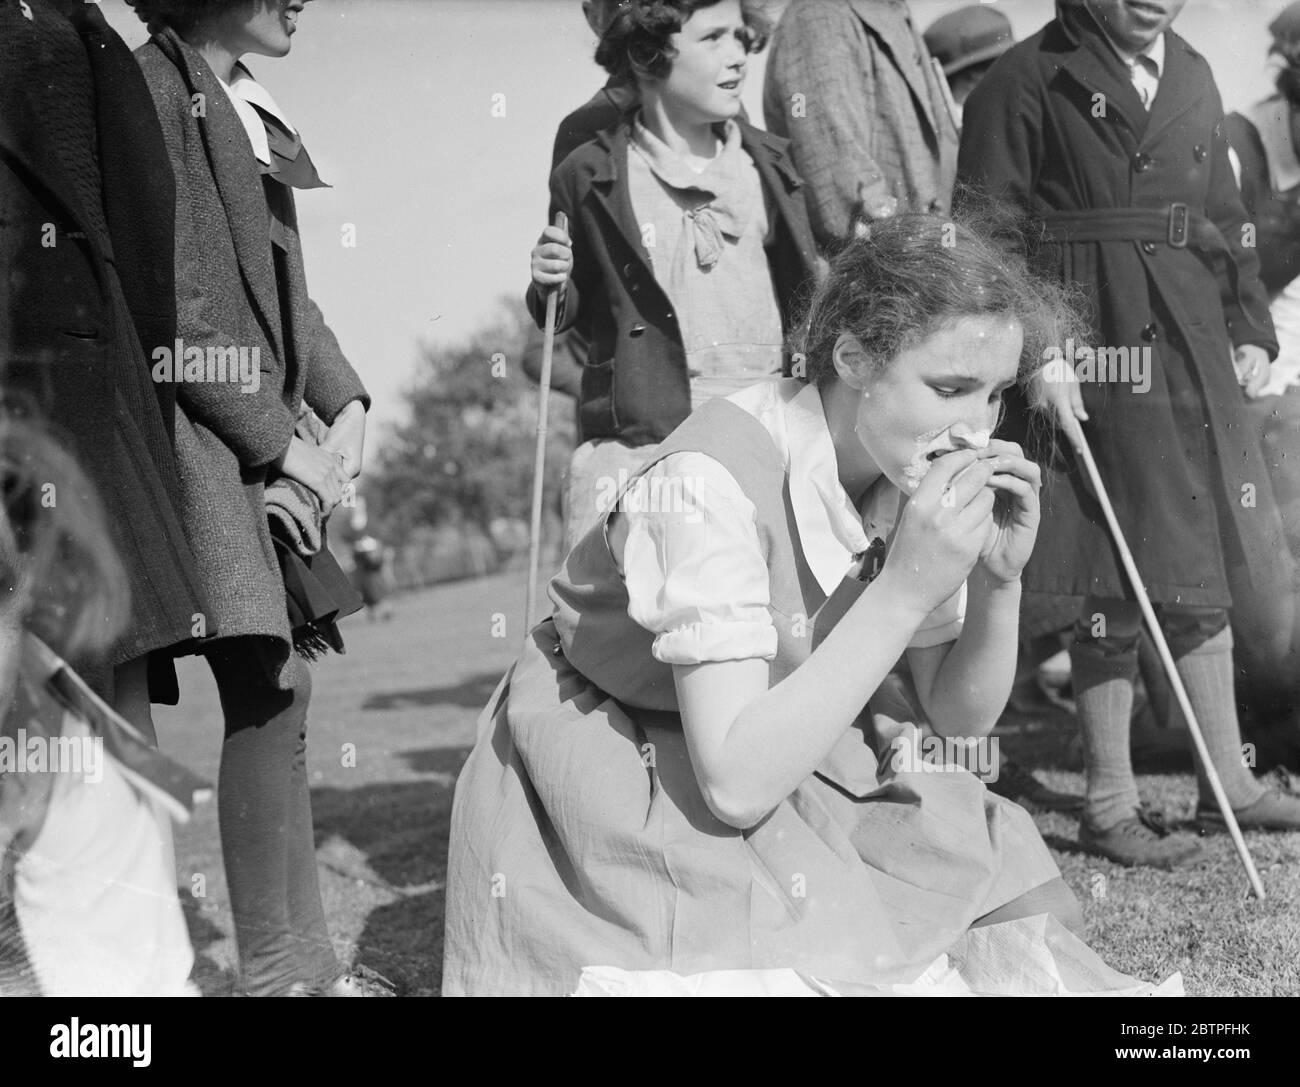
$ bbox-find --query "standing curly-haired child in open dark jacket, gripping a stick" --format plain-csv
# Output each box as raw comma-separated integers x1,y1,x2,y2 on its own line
528,0,815,542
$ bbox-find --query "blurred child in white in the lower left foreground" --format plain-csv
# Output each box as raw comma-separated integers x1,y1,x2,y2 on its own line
0,416,195,996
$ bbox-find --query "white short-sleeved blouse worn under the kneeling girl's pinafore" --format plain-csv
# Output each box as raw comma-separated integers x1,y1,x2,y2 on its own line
619,378,966,664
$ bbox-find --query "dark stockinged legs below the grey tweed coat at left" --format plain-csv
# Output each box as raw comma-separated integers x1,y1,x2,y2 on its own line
208,638,343,996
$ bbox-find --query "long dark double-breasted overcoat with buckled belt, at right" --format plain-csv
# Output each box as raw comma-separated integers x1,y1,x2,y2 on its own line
959,4,1284,607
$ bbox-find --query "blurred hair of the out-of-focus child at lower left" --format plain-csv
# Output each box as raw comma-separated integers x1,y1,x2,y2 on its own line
0,412,130,661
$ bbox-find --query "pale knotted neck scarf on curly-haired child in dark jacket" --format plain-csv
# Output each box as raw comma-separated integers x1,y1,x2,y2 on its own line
632,113,754,270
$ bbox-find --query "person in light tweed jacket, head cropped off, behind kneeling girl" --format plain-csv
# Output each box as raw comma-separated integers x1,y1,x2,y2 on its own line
763,0,957,251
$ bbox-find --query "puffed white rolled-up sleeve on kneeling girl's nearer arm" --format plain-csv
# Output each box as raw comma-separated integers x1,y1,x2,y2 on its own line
619,452,776,664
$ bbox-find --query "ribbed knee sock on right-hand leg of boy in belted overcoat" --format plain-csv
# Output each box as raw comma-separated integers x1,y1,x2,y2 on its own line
1174,627,1265,809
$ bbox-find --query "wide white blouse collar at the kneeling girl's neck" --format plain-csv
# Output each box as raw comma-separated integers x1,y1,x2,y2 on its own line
727,377,901,596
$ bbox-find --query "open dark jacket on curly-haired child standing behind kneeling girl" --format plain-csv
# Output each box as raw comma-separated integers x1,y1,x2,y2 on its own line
525,120,816,445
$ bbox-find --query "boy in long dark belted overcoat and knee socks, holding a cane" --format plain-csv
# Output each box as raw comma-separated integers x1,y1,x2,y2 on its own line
958,0,1300,867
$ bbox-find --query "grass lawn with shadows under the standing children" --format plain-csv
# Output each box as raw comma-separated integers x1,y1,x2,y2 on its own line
157,575,1300,996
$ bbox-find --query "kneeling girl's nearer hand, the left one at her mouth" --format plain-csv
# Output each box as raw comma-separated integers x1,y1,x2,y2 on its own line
880,443,1005,614
